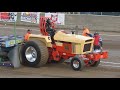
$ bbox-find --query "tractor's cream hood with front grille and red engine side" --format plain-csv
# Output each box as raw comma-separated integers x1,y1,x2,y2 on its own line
54,31,94,54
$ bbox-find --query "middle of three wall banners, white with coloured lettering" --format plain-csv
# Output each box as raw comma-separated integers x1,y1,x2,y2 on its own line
21,12,40,24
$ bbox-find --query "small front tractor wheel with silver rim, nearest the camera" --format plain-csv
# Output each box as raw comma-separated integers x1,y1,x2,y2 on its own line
71,57,85,71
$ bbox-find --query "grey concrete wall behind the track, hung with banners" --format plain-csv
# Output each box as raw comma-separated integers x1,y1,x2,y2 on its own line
0,12,120,32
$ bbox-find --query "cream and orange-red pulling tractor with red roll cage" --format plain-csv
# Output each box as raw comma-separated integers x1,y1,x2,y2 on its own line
20,17,108,71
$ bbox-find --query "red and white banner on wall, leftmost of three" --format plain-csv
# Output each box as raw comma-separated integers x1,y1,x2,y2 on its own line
0,12,17,22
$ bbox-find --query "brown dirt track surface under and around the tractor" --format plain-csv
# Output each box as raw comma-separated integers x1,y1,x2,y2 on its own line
0,26,120,78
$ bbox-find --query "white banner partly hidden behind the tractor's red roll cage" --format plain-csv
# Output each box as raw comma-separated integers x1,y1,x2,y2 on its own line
45,13,65,25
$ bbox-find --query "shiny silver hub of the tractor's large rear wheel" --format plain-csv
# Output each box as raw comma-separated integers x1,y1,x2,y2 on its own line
25,46,37,62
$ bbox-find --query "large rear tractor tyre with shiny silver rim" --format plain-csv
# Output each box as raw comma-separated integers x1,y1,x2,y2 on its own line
21,39,49,67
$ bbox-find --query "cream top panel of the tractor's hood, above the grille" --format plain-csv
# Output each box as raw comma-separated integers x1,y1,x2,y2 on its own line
54,31,94,43
